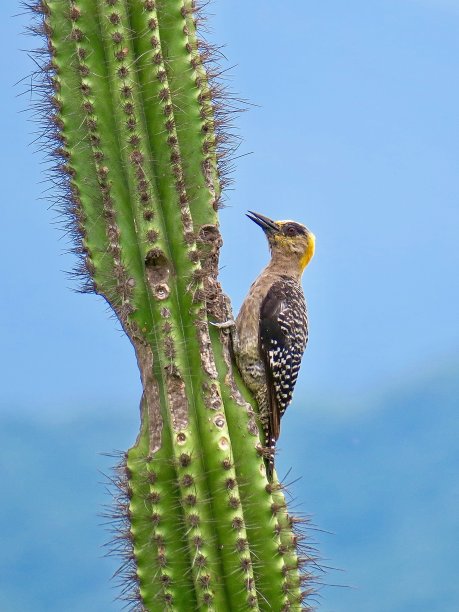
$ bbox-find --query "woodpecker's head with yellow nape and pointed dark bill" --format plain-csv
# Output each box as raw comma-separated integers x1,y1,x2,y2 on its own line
247,210,316,271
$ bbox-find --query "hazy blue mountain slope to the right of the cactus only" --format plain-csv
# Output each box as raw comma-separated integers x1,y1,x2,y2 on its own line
279,364,459,612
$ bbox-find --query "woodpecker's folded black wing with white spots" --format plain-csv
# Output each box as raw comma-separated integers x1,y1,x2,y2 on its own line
259,276,308,448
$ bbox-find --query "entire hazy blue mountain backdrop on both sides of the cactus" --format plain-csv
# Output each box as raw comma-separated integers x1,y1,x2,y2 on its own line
0,360,459,612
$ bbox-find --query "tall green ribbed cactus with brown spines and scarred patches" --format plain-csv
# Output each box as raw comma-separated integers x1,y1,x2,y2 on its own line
30,0,314,612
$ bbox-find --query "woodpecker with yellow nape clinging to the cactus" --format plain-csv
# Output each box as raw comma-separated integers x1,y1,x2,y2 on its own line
233,211,315,482
